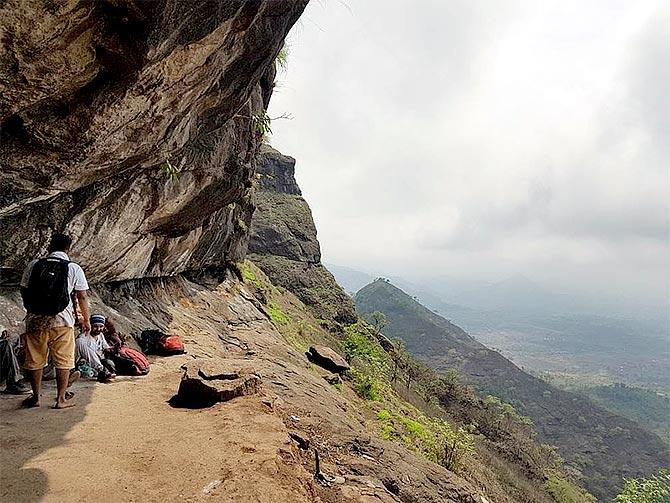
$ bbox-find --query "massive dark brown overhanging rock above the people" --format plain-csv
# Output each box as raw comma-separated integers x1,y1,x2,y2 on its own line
0,0,307,284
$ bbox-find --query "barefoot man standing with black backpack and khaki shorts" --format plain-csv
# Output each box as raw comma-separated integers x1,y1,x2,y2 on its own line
21,234,91,409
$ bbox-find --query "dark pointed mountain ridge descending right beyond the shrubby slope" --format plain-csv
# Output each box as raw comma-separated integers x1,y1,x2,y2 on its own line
355,280,670,500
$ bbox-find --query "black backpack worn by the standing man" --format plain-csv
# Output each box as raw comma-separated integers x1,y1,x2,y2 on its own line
21,257,70,316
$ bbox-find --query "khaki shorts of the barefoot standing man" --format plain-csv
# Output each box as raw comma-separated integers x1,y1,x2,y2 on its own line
23,327,74,370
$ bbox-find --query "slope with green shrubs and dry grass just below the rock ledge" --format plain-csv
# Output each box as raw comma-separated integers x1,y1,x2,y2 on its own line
238,261,592,503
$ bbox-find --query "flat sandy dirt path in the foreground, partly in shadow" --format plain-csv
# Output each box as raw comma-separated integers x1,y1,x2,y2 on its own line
0,356,314,503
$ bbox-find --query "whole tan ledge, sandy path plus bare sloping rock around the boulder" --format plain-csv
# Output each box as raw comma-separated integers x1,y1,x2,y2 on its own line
0,278,479,503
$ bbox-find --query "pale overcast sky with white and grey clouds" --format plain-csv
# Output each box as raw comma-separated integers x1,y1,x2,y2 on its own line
270,0,670,308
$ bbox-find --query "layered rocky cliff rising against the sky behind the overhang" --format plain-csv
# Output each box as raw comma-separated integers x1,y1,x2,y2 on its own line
249,145,356,324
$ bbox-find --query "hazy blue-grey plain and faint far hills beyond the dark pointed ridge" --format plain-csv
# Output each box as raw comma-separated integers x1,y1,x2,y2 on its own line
329,266,670,390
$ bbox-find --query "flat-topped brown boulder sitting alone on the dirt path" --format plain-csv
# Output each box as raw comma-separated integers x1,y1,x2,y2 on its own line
174,360,261,408
